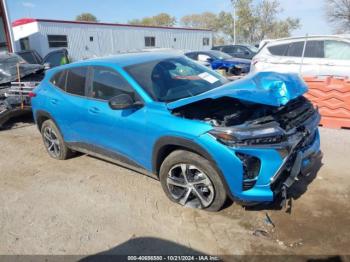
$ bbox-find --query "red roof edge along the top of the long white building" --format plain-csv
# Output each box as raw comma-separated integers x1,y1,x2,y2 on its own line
12,18,212,32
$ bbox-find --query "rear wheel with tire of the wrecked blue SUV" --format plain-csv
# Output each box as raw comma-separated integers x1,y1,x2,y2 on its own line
41,120,73,160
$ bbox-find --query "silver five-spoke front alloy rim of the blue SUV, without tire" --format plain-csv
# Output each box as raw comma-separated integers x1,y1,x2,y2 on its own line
166,163,215,208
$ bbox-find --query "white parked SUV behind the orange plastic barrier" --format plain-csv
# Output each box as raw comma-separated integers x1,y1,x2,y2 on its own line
252,36,350,76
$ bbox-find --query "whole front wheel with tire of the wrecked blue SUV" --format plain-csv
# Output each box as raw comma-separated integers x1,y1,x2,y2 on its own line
159,150,227,211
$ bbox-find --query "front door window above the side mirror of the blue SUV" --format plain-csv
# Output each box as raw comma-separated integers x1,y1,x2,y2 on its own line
91,66,136,101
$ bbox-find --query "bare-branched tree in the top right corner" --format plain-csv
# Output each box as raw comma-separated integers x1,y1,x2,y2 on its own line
326,0,350,33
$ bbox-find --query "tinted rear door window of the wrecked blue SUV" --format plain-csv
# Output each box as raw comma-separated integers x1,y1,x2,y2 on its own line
66,67,87,96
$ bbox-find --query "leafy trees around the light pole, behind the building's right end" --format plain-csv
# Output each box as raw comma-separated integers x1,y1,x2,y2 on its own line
181,0,300,44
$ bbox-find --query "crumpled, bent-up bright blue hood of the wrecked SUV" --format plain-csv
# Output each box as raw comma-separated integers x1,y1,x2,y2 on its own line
167,72,308,109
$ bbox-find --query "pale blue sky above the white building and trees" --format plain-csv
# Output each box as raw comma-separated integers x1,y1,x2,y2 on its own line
7,0,331,36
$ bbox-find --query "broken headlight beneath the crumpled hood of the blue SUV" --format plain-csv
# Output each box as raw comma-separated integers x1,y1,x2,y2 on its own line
209,126,285,146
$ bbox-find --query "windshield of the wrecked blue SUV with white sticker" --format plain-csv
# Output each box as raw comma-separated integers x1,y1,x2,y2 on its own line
124,57,227,102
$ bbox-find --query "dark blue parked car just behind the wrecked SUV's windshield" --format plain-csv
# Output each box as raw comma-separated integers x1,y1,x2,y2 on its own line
185,50,250,75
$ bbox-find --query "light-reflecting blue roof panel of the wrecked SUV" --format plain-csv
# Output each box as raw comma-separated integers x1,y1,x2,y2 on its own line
66,52,181,67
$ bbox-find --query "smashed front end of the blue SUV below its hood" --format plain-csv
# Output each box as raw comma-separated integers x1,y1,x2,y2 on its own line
172,72,320,205
